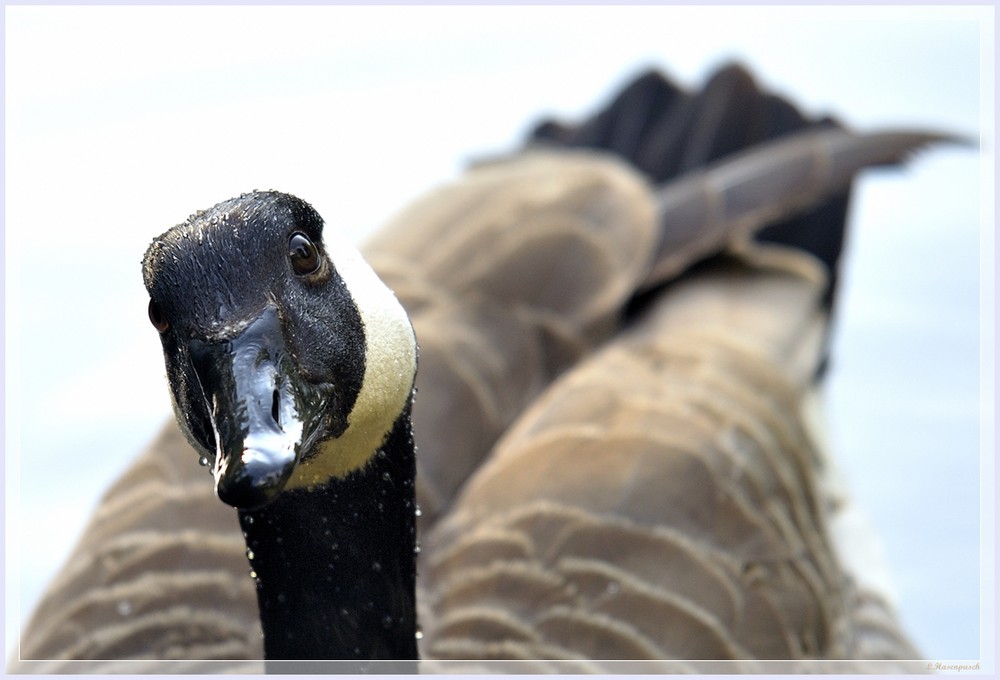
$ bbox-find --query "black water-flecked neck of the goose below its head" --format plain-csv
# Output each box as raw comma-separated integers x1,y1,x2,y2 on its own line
239,408,417,661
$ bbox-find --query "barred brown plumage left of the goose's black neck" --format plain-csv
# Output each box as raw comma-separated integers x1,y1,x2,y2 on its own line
9,422,263,673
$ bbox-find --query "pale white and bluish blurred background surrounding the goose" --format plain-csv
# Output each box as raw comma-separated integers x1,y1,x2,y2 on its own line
5,6,995,660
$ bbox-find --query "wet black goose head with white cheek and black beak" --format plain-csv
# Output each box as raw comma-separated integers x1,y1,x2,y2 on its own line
143,192,416,510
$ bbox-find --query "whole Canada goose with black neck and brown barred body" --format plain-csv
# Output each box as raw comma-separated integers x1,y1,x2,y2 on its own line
13,69,952,676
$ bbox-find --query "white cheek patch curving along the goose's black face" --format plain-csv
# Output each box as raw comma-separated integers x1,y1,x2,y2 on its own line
286,236,417,488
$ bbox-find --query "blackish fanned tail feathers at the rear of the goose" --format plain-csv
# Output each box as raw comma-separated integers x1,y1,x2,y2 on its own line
530,64,849,303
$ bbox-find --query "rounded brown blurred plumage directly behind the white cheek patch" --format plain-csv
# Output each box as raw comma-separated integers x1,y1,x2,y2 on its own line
364,152,658,530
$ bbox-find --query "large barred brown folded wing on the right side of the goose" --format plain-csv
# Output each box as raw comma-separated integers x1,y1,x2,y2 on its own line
414,253,916,671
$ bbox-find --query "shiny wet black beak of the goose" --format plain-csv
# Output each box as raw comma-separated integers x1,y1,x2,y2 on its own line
188,306,319,510
